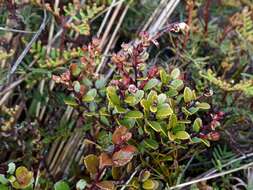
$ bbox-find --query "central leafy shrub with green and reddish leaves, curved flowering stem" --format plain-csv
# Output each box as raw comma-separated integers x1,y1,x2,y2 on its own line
53,23,222,189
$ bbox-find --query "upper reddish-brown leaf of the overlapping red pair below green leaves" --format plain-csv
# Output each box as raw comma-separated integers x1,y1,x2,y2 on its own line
112,126,132,144
